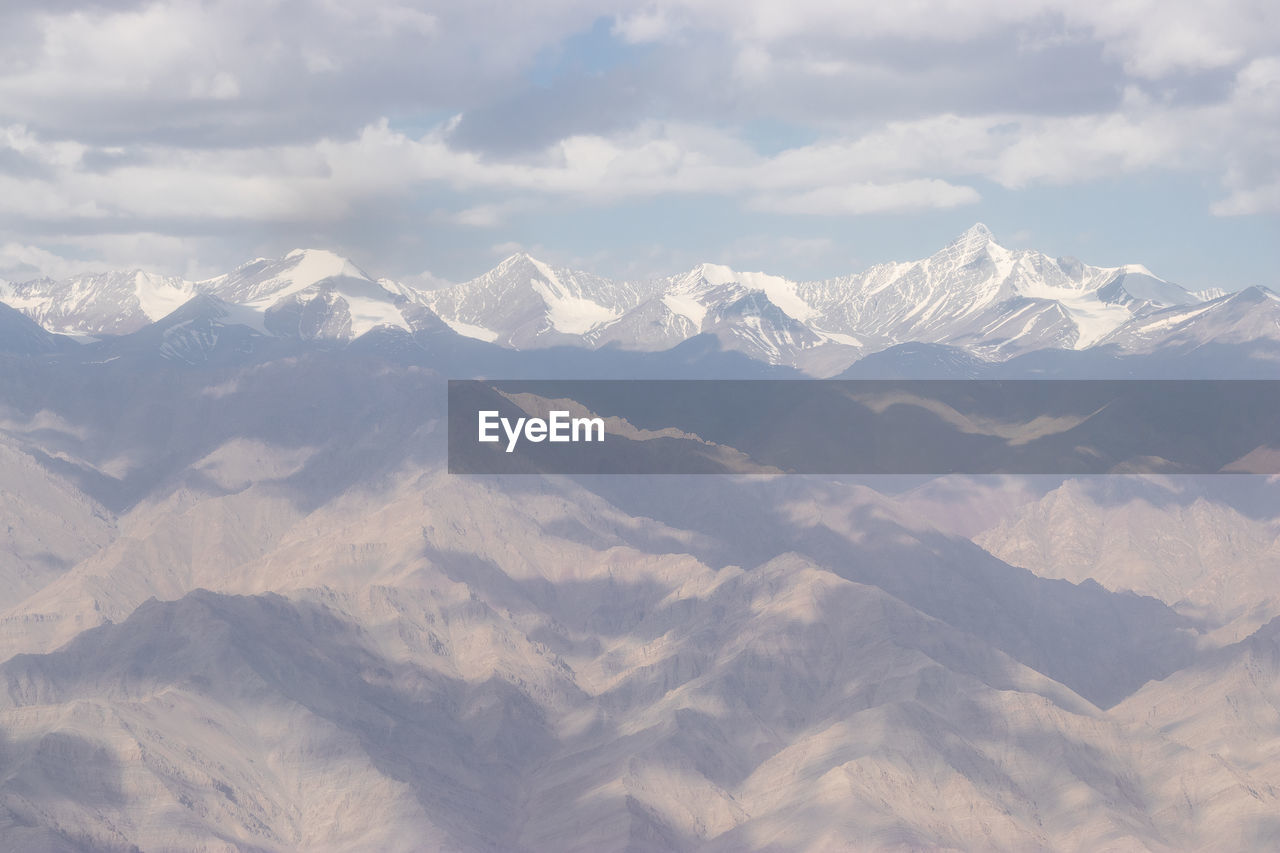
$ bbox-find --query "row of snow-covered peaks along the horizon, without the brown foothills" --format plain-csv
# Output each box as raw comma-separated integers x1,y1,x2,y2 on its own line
0,224,1264,377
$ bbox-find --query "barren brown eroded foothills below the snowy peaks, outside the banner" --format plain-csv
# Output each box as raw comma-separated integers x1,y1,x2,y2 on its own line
0,333,1280,850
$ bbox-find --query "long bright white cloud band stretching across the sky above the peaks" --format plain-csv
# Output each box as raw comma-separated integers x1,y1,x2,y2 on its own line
0,73,1259,227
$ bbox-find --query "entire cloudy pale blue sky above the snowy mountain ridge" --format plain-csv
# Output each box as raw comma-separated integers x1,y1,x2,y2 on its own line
0,0,1280,288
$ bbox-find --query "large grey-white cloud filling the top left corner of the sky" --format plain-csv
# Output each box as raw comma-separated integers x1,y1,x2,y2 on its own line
0,0,599,145
